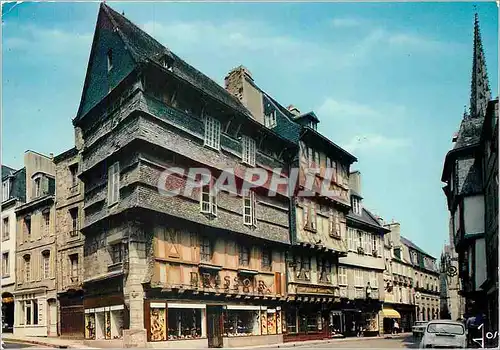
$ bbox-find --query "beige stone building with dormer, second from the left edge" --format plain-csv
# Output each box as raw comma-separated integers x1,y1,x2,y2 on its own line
13,151,57,336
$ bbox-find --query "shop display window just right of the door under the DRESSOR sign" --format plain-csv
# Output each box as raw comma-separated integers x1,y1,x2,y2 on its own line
224,310,260,337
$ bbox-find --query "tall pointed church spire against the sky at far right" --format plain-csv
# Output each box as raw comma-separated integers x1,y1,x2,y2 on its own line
470,12,491,118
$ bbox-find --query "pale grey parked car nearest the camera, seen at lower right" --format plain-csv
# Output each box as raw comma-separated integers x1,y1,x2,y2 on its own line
420,320,467,349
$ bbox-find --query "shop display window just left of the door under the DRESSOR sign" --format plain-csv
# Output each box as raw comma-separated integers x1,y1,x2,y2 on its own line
167,309,202,340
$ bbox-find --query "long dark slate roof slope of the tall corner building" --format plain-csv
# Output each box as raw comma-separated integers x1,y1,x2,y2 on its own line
101,3,252,117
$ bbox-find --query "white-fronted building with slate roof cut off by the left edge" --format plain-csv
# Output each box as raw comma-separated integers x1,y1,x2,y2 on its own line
1,165,26,332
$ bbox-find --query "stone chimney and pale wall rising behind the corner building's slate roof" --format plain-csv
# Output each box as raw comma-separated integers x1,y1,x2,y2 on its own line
224,66,264,124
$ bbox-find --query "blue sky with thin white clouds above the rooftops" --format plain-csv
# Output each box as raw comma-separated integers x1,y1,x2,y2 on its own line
2,2,498,257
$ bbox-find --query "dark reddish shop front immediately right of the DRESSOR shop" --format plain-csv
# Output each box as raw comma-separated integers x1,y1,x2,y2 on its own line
283,303,330,342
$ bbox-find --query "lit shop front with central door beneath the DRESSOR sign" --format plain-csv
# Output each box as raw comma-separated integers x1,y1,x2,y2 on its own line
144,300,283,348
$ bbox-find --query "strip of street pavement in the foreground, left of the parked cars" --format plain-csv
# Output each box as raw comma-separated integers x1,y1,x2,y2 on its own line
296,336,418,349
